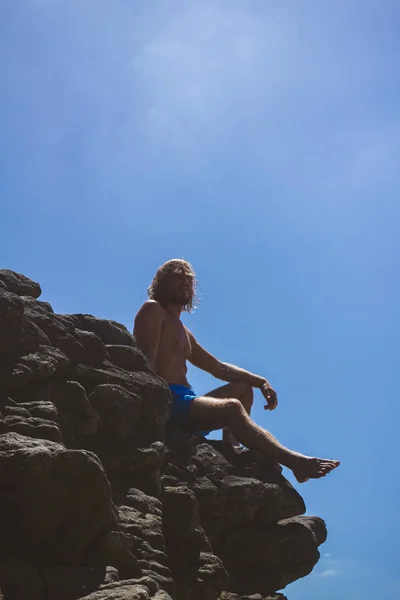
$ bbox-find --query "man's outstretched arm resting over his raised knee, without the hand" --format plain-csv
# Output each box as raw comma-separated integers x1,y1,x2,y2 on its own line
186,329,270,388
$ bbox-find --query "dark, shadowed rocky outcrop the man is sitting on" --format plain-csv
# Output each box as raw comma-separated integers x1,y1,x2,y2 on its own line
0,270,326,600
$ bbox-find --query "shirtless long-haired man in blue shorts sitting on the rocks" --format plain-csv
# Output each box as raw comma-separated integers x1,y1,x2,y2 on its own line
134,259,339,483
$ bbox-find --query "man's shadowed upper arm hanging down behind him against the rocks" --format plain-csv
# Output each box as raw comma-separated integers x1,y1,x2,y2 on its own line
133,300,165,371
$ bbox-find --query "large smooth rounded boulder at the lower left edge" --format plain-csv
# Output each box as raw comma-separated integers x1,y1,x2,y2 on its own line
0,433,116,566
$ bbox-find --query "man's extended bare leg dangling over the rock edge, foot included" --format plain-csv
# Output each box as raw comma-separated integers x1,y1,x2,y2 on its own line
188,396,340,482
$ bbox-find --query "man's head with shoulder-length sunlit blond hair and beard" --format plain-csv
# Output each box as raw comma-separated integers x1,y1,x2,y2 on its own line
147,258,197,312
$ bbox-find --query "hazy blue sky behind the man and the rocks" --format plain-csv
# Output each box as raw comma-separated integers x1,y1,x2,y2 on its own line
0,0,400,600
